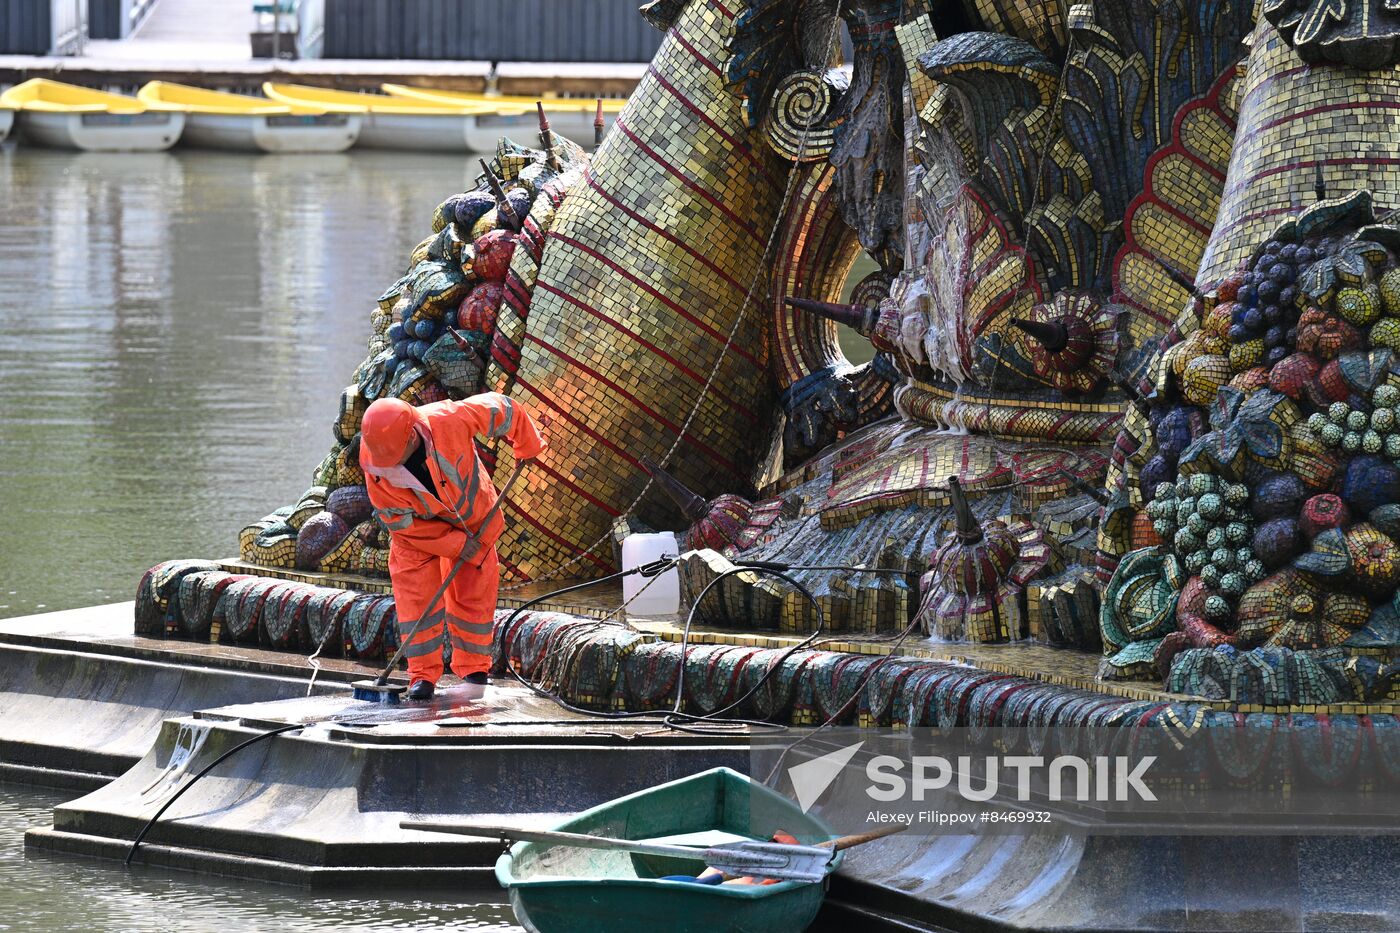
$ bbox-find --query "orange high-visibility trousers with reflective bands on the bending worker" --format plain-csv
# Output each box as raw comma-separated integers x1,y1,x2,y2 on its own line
389,535,500,684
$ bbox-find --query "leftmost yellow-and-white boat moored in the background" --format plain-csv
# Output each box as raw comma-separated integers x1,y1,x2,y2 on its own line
0,78,185,153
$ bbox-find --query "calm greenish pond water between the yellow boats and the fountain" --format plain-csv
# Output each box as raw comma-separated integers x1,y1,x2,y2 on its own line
0,146,472,618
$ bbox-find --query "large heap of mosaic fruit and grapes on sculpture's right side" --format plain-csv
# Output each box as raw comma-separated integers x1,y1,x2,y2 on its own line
1102,192,1400,682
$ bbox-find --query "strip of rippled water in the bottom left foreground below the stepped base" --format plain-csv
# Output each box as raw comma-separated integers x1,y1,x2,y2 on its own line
0,785,519,933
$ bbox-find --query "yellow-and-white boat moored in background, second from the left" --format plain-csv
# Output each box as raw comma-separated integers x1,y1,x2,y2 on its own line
137,81,363,153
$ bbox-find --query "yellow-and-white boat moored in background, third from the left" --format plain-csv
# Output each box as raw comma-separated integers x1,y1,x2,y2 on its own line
263,81,529,153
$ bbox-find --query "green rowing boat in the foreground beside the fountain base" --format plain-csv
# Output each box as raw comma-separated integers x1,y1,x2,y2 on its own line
496,768,843,933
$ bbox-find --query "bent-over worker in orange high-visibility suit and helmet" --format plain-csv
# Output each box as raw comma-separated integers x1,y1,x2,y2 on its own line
360,392,545,699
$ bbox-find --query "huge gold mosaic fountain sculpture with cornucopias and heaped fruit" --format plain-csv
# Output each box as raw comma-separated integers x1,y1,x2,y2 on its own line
204,0,1400,705
